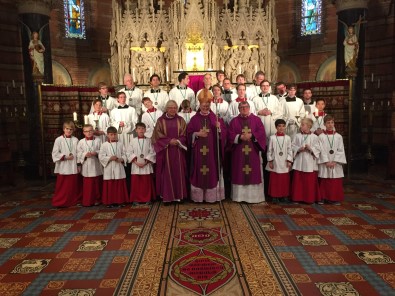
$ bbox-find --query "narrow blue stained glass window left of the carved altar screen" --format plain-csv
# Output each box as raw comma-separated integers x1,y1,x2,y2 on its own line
63,0,85,39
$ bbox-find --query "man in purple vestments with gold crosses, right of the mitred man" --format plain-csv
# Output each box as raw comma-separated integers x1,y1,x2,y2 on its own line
228,101,266,203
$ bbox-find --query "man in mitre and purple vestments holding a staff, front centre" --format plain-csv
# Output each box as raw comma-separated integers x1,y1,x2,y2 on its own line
187,89,226,202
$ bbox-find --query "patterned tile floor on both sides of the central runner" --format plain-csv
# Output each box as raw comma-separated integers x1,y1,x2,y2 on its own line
0,175,395,296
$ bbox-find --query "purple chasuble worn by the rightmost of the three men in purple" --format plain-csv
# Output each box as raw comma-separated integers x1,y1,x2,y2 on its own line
228,114,266,185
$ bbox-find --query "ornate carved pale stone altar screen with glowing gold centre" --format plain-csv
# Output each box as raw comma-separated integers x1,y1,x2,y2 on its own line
109,0,280,85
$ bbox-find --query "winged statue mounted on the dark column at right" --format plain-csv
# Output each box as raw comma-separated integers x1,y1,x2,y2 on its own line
339,16,364,69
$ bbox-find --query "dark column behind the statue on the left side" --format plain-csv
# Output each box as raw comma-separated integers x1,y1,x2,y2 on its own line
17,0,53,178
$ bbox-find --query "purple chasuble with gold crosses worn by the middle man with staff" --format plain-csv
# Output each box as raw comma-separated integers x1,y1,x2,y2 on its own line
187,112,226,189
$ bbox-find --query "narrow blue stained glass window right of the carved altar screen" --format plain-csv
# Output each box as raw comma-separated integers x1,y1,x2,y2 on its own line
301,0,322,36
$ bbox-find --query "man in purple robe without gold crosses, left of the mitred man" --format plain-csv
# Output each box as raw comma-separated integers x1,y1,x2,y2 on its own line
152,100,187,203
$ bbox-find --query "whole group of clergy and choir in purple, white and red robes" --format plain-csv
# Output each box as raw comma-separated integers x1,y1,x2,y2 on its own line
52,71,346,207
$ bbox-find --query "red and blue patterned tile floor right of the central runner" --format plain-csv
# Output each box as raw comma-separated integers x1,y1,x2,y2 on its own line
251,180,395,296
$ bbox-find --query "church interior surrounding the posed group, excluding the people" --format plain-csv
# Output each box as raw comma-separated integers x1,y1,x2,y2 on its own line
0,0,395,295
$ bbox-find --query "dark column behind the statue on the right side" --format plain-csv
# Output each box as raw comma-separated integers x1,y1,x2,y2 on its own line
336,0,368,177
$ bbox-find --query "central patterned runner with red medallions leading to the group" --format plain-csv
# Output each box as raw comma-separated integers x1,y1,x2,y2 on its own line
115,202,300,295
